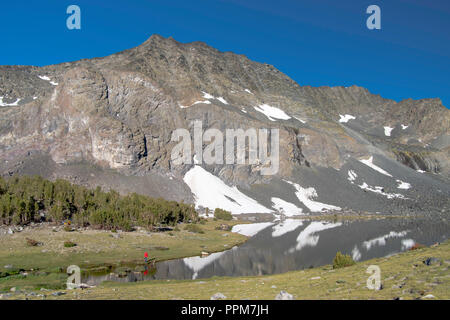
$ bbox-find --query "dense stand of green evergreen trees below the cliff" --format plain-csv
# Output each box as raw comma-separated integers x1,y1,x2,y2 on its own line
0,176,198,231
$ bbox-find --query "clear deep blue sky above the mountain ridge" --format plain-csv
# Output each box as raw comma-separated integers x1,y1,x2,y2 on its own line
0,0,450,107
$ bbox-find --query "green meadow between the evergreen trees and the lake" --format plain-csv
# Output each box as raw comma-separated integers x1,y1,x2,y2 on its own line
0,220,247,291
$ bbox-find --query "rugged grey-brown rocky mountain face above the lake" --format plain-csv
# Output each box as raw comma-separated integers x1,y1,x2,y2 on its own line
0,35,450,215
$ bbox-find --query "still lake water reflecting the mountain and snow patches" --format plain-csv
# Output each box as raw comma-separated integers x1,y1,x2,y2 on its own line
82,218,450,285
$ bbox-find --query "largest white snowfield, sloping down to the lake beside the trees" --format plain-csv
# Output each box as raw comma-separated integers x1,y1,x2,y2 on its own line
183,165,273,214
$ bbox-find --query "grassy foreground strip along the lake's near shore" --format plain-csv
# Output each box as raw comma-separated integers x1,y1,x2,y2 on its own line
16,242,450,300
